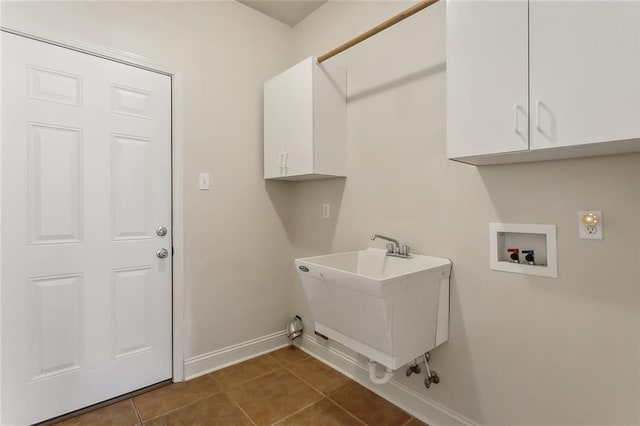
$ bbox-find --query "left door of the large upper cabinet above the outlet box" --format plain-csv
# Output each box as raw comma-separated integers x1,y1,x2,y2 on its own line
447,0,529,158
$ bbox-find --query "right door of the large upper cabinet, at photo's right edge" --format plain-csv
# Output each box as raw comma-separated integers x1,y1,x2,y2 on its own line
530,0,640,149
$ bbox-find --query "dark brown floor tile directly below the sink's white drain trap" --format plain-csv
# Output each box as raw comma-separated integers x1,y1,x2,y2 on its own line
329,383,410,426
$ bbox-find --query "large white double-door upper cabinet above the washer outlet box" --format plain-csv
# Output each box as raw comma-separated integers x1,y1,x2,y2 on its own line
447,0,640,165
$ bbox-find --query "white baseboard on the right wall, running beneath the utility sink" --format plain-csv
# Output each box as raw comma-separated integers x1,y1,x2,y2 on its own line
300,334,478,426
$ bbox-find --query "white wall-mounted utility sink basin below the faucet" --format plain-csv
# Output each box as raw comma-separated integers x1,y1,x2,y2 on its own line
295,248,451,369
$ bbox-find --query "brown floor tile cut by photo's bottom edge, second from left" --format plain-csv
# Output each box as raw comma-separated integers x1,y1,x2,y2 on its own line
145,393,253,426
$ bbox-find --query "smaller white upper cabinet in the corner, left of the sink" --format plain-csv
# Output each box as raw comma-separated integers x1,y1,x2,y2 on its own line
264,58,347,180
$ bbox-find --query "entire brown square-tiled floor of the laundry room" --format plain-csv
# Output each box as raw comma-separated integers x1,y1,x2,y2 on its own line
53,347,424,426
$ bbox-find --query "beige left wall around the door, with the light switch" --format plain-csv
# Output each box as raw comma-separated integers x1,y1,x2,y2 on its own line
2,1,291,358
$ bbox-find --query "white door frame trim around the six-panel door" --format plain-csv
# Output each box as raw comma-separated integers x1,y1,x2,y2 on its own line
0,16,185,392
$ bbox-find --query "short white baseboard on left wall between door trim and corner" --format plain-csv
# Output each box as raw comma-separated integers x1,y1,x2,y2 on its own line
184,330,289,380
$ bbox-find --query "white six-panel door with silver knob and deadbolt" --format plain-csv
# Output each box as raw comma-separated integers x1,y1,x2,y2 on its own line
0,33,171,425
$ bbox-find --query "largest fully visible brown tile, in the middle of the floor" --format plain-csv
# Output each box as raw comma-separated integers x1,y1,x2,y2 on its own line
227,369,322,425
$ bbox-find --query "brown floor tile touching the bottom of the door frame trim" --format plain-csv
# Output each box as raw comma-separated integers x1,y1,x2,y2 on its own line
133,375,220,421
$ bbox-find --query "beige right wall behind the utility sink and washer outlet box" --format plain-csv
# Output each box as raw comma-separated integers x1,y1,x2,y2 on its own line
289,1,640,425
